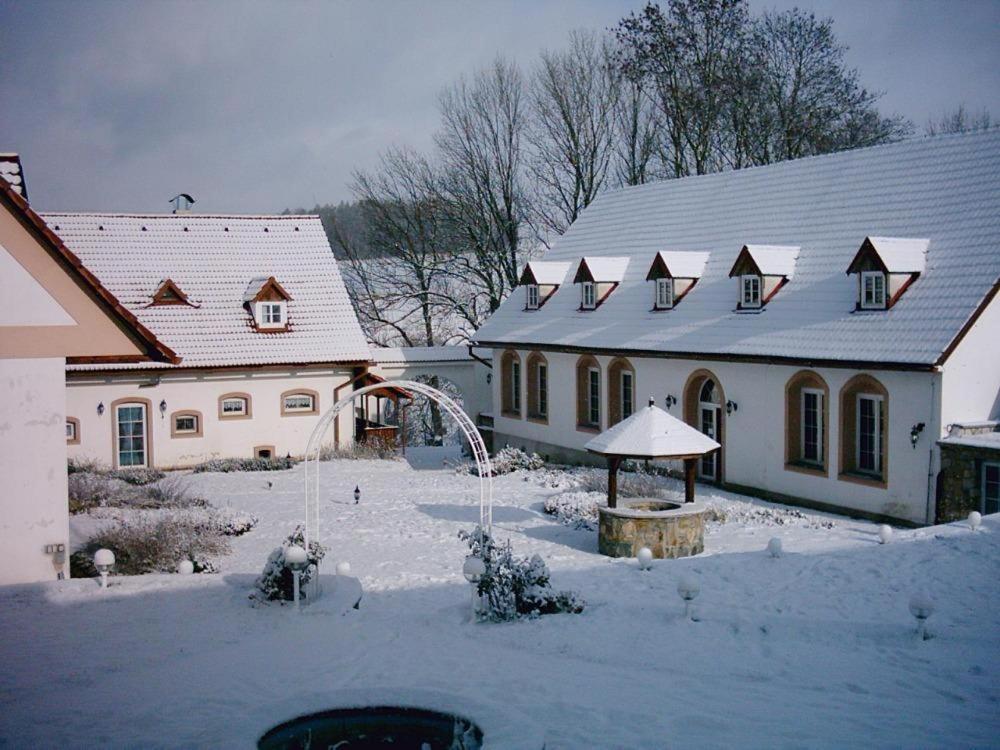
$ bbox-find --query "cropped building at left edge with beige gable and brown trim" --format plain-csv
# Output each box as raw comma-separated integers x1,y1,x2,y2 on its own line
0,172,175,585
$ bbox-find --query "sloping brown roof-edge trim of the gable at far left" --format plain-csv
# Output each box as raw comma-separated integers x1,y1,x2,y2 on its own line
0,179,181,364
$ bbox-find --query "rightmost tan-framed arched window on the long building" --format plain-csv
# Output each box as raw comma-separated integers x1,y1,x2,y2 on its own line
840,375,889,486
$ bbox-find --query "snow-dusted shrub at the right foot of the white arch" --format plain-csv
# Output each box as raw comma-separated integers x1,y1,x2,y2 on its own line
458,527,586,622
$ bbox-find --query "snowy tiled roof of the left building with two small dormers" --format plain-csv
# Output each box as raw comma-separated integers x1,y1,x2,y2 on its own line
44,213,370,369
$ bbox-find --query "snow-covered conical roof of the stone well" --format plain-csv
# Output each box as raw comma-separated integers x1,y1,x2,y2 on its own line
584,404,721,459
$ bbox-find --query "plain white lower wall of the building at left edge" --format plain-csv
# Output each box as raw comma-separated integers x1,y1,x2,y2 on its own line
0,358,69,585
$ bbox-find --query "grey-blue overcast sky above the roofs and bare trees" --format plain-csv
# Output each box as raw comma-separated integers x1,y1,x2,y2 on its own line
0,0,1000,213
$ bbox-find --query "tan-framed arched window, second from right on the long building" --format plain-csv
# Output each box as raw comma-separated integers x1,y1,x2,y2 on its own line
785,370,830,474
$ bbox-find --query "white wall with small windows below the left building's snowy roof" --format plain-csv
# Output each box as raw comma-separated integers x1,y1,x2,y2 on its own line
66,368,354,468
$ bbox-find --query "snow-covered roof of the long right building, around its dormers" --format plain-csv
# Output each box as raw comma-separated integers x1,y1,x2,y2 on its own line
473,129,1000,367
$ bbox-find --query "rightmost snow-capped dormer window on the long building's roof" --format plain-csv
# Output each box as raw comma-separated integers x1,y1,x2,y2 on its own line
847,237,930,310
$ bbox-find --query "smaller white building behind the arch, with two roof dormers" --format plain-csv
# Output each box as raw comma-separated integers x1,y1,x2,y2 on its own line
44,213,371,468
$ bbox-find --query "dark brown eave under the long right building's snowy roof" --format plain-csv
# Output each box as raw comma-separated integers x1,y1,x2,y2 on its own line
472,342,936,372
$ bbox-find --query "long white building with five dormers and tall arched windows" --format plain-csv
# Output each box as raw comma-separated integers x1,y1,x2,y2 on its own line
474,130,1000,523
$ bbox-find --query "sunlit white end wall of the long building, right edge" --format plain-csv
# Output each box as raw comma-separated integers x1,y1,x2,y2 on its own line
941,295,1000,428
